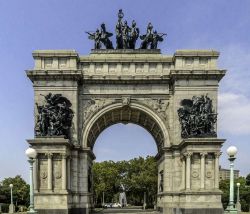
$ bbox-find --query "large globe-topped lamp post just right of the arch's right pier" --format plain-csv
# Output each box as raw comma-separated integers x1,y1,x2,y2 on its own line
226,146,238,213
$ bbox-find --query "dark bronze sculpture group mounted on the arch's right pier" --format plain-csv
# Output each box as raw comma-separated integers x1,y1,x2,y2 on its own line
178,95,217,138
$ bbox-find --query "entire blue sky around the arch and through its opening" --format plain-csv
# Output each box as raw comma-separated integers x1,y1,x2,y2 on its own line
0,0,250,180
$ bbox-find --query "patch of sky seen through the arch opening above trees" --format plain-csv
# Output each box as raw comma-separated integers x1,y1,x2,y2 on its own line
93,123,157,162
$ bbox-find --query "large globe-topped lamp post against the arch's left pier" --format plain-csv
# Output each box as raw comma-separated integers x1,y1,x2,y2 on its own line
25,148,37,213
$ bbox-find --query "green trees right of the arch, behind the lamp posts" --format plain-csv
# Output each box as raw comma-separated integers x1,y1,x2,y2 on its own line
220,176,250,212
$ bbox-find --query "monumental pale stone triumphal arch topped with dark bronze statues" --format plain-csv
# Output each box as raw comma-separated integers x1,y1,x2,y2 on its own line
27,10,225,214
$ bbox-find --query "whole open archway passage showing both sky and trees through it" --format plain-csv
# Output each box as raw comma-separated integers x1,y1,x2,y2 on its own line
92,123,157,208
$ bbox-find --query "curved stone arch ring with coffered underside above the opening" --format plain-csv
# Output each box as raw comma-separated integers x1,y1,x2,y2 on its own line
82,103,170,153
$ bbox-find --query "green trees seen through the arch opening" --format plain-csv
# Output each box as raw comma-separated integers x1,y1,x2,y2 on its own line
93,156,157,206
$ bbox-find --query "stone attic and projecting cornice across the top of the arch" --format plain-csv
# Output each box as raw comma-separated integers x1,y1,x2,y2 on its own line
27,49,225,83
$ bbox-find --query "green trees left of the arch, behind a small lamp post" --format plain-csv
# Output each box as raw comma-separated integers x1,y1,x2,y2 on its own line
0,175,29,206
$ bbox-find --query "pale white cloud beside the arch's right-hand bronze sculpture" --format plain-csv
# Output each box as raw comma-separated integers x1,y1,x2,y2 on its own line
218,93,250,135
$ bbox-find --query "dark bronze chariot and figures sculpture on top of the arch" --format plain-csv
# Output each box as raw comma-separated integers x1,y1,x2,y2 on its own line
86,9,166,49
